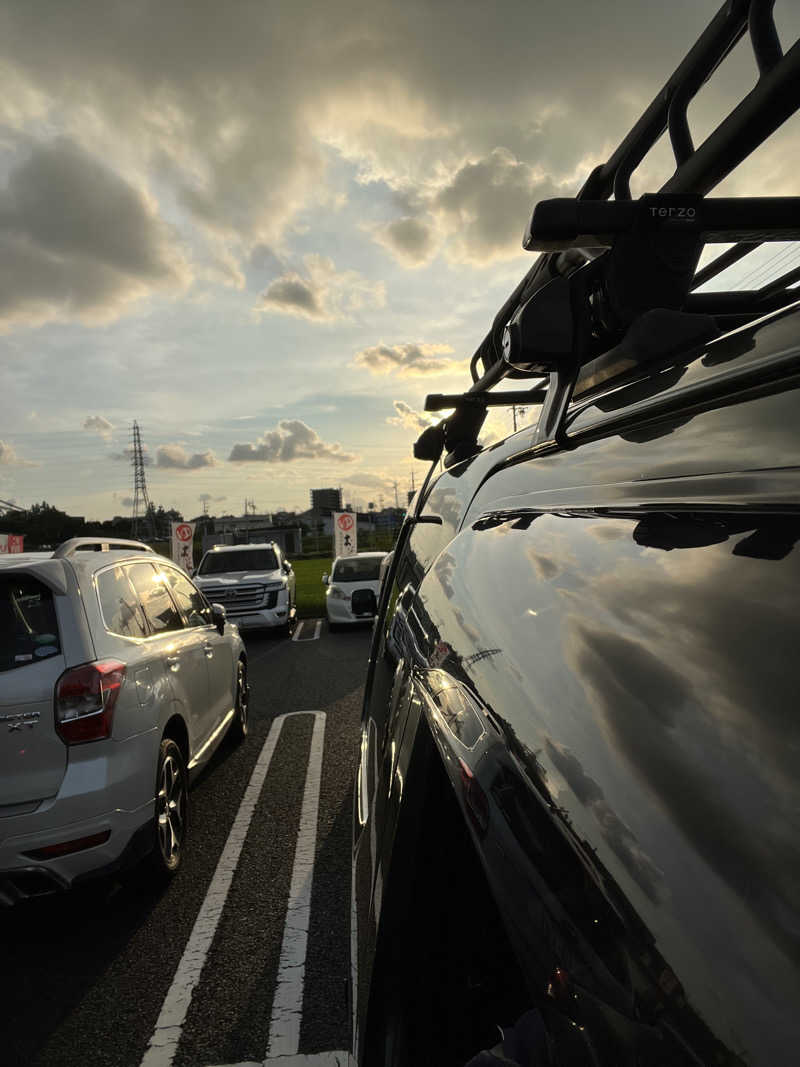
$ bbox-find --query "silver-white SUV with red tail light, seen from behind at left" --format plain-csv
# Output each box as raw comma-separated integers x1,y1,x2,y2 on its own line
0,538,249,904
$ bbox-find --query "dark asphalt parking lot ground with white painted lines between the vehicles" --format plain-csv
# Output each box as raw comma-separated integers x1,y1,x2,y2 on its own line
0,620,370,1067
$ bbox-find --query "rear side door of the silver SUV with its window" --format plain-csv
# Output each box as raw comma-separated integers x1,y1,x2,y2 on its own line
128,560,213,762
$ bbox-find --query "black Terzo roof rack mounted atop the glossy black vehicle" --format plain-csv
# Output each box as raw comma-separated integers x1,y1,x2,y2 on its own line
415,0,800,465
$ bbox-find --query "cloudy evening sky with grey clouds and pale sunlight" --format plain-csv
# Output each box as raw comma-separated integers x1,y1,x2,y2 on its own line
0,0,800,517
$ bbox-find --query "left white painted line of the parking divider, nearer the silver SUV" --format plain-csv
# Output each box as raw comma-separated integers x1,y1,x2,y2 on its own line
142,712,325,1067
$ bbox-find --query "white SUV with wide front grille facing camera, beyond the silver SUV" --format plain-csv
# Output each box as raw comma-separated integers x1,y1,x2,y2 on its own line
194,541,295,634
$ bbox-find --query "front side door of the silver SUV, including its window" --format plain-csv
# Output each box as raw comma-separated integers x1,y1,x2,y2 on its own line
161,566,236,733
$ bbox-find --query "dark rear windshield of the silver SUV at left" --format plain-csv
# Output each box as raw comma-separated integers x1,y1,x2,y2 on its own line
0,574,61,671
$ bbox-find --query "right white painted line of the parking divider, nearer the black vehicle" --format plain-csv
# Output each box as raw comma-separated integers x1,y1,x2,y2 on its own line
267,712,325,1062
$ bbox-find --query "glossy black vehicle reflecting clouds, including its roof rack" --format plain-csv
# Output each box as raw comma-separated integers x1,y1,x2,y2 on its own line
353,0,800,1067
